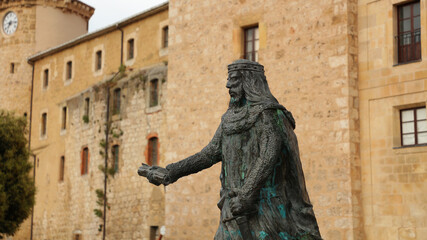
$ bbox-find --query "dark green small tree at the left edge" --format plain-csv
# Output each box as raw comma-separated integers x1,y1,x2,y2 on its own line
0,110,35,238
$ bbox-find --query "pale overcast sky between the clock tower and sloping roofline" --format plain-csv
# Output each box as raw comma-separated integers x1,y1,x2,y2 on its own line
80,0,167,32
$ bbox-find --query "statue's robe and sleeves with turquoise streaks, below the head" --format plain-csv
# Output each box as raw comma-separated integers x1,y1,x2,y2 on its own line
166,103,321,240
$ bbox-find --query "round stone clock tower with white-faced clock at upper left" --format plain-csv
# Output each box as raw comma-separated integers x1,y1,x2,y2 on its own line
0,0,95,116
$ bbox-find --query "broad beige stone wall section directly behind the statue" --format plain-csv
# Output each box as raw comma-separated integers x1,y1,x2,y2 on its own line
166,0,363,239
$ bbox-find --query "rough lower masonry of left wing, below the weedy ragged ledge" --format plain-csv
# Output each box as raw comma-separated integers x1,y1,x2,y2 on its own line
34,65,167,240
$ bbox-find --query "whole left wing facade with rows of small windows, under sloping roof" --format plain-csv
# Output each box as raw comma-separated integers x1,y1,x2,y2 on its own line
14,4,168,240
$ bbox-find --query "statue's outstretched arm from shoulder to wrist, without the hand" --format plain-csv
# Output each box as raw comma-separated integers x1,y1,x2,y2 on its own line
166,125,222,183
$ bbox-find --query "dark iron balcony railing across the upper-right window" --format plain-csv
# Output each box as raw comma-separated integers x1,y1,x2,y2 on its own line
396,29,421,63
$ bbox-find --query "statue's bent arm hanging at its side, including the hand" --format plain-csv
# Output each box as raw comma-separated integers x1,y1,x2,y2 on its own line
231,110,282,215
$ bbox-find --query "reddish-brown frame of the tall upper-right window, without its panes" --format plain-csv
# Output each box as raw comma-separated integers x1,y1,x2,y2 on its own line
396,0,422,64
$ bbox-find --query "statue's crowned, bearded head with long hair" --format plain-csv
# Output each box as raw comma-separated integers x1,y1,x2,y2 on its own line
226,59,277,105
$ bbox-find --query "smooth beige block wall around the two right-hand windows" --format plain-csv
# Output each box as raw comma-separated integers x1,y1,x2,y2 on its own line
358,0,427,239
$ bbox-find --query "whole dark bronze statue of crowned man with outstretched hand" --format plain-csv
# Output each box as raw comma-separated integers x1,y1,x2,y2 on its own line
138,59,321,240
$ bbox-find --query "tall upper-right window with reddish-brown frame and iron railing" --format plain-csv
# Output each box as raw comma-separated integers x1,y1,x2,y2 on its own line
397,1,421,63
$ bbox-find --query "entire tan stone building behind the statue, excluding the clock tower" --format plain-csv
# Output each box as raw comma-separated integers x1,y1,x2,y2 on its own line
0,0,427,240
